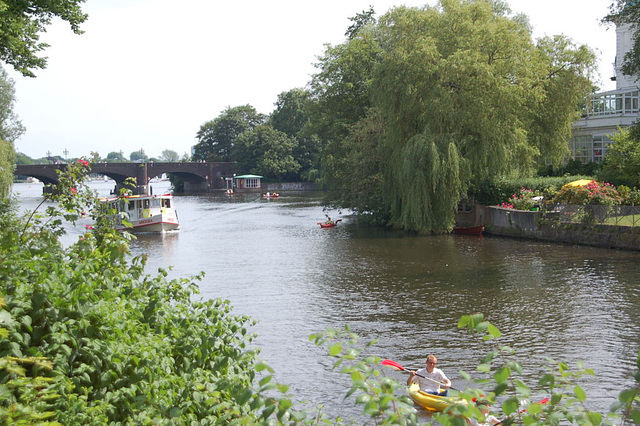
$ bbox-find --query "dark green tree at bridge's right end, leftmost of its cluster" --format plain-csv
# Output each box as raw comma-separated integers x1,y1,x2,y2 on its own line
193,105,266,161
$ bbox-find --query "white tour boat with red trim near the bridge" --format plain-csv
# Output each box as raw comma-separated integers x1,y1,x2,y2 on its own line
100,194,180,232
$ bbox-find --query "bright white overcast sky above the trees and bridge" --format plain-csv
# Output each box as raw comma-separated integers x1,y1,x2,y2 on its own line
3,0,615,158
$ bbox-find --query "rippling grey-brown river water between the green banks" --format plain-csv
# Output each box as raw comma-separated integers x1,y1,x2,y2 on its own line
14,182,640,423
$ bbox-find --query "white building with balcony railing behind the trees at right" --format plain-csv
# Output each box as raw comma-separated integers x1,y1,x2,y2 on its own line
569,25,640,163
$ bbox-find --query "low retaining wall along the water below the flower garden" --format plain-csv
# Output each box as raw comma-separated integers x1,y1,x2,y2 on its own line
456,206,640,251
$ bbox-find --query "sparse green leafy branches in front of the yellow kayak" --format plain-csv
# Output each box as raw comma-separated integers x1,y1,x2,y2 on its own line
310,314,640,426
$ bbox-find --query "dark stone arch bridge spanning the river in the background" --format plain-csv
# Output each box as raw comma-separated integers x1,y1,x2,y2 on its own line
14,162,236,194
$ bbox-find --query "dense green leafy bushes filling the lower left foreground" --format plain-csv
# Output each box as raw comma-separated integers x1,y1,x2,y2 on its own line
0,160,317,425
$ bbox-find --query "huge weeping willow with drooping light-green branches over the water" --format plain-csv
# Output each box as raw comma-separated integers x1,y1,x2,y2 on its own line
313,0,593,232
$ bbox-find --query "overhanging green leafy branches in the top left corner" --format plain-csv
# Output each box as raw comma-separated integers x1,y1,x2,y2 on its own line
0,0,87,77
